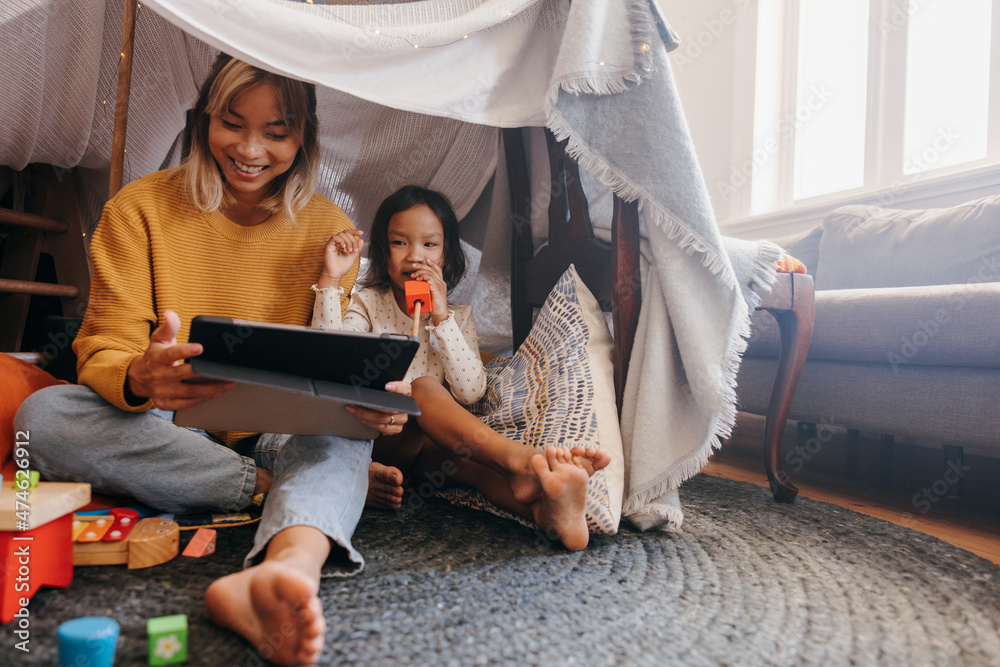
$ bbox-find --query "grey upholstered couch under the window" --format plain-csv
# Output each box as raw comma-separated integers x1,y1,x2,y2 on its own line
737,196,1000,464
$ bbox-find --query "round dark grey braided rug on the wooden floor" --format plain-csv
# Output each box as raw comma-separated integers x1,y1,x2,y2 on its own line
0,475,1000,667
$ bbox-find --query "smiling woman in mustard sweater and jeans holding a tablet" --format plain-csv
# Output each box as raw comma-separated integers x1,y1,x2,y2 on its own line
16,56,400,664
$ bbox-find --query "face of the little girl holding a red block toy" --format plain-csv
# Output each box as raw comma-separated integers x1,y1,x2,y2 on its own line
388,204,444,290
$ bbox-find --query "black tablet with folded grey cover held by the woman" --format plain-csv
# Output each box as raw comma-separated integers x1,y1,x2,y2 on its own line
174,316,420,439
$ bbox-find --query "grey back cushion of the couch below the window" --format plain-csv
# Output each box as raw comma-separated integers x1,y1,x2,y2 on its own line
812,195,1000,290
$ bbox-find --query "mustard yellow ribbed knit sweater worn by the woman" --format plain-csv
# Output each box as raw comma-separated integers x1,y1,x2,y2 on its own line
73,170,358,440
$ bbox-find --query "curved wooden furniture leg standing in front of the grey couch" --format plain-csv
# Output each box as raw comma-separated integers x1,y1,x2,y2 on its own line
758,273,816,503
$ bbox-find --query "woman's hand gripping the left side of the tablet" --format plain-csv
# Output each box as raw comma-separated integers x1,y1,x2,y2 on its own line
125,310,236,410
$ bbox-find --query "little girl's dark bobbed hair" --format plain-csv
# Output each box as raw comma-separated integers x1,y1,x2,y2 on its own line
361,185,466,291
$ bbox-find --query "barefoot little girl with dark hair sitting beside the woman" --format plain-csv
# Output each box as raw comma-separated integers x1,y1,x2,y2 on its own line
313,185,610,549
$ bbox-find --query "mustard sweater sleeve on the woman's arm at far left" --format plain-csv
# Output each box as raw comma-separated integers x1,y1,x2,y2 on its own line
73,200,157,412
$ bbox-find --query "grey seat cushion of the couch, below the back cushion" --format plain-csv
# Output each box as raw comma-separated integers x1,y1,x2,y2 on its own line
744,283,1000,369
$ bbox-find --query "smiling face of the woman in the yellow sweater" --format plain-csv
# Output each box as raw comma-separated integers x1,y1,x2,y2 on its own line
208,83,302,205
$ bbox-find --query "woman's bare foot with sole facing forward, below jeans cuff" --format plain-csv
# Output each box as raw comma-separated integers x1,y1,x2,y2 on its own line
205,560,326,665
